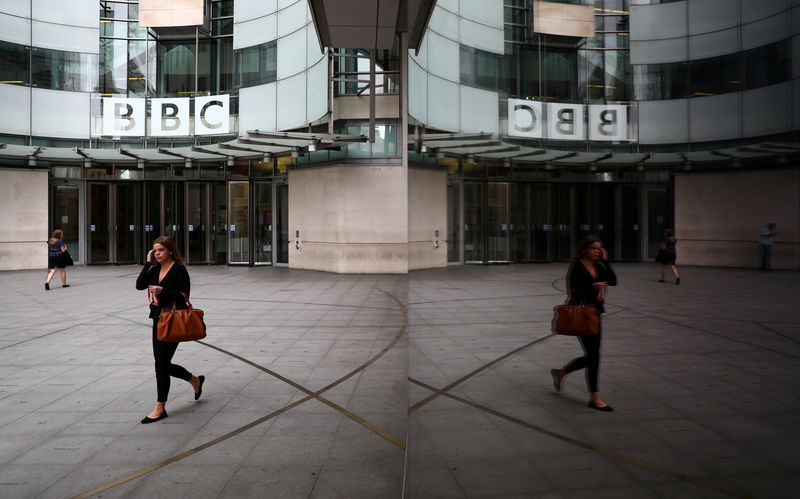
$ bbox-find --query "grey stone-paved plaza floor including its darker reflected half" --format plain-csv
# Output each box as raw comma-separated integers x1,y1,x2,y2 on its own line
0,264,800,498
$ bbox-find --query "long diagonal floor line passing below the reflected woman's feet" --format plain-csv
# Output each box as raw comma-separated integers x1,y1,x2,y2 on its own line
408,378,750,499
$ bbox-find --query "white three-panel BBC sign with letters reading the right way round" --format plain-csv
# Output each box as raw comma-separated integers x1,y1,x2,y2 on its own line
103,95,230,137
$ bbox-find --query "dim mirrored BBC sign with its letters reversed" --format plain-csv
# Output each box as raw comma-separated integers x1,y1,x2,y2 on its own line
508,99,628,142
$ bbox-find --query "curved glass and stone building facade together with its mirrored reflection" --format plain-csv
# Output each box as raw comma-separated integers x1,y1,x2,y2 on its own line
0,0,800,274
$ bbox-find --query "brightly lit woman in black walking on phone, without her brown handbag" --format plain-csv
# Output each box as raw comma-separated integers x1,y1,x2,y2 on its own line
136,236,205,424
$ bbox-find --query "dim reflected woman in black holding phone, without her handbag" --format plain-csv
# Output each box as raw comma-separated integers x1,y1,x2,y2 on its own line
550,235,617,412
